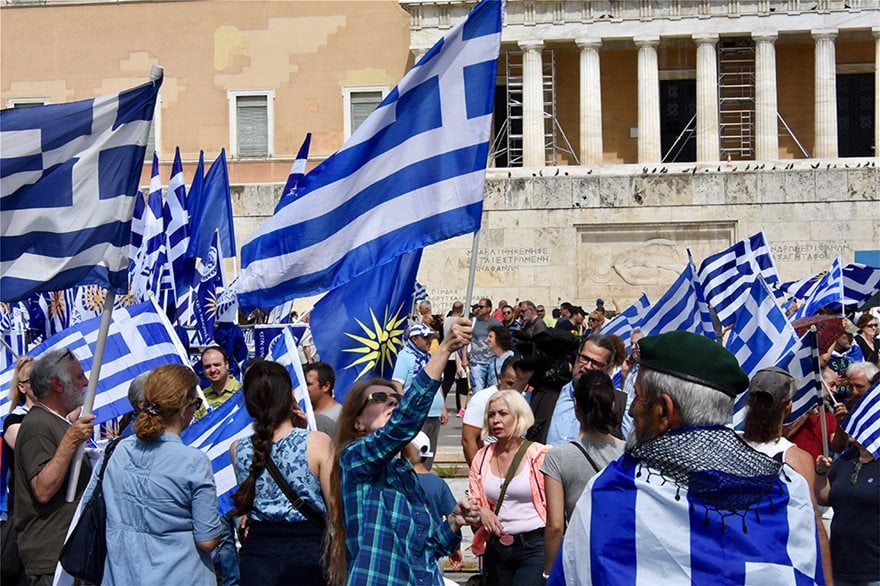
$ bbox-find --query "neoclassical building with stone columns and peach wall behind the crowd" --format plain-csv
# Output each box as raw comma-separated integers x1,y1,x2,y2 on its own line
0,0,880,309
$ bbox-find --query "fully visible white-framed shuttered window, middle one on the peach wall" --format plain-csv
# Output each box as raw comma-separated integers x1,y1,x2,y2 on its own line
229,90,275,159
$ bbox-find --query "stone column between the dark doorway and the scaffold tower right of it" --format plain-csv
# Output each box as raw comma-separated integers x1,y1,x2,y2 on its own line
694,34,721,163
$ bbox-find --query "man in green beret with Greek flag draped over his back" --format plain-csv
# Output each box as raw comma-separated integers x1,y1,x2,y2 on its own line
548,332,825,585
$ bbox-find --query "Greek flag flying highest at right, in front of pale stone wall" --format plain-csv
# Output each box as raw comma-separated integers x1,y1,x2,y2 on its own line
699,232,779,326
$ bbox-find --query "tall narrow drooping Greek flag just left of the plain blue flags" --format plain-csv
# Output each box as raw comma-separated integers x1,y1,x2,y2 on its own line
162,147,195,316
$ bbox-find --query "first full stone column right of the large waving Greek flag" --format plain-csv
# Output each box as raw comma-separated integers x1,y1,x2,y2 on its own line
519,41,546,167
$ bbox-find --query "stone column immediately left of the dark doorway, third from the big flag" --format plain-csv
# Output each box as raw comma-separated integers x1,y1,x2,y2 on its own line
633,37,662,163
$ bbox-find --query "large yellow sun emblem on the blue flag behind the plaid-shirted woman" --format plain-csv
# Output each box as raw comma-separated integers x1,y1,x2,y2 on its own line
343,304,406,381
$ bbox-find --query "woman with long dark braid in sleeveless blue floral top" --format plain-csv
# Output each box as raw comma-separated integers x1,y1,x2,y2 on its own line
229,362,333,586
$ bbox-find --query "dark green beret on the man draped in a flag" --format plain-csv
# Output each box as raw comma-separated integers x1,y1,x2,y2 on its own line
639,332,749,397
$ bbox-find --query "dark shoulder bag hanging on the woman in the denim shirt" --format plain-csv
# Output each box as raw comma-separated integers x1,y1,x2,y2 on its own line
59,439,119,584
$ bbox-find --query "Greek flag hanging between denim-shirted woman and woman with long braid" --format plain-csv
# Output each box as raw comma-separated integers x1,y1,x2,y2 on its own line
180,391,254,514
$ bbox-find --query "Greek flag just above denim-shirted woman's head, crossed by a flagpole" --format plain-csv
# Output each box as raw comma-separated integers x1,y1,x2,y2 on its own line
0,300,189,423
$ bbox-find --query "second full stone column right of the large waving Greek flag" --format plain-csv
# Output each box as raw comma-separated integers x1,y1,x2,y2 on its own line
575,38,603,165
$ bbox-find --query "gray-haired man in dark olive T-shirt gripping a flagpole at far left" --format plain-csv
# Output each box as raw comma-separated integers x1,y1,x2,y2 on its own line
14,350,95,585
